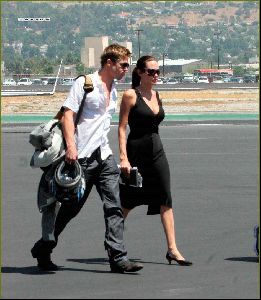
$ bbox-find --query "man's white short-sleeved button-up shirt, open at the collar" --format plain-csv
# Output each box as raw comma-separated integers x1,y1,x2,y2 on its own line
63,71,117,160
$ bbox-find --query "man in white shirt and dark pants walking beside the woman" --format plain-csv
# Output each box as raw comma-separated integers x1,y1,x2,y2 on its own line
31,44,143,273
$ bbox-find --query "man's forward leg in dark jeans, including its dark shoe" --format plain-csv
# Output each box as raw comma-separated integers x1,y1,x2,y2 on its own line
96,155,143,273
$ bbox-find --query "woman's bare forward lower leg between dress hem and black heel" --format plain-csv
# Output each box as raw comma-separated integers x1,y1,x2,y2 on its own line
160,205,184,260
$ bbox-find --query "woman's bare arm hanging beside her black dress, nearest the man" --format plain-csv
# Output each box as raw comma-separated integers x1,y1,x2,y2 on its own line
118,89,136,175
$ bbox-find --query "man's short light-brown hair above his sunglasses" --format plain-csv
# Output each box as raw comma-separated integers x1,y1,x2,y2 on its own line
101,44,131,67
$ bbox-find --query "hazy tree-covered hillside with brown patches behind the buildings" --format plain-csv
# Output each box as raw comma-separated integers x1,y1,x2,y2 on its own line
1,1,259,73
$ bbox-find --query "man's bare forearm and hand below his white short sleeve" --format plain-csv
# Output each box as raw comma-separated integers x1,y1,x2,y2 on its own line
62,108,78,163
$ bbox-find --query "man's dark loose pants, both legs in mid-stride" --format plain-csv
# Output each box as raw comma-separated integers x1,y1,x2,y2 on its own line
34,148,127,262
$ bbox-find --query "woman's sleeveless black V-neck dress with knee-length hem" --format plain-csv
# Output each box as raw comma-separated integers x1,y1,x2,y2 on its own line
120,90,172,215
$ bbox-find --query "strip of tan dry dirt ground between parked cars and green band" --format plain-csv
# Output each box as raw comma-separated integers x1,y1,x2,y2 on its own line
1,89,259,114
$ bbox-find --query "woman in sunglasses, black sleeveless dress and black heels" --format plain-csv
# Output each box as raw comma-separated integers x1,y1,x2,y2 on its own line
118,56,192,266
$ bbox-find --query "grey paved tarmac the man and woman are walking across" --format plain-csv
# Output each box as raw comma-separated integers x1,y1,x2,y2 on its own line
2,123,260,299
